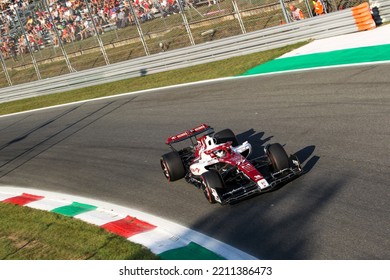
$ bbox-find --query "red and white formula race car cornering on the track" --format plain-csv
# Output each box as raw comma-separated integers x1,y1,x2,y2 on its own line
160,124,302,204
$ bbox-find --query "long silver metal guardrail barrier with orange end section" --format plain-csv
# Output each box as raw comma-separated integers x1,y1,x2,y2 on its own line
0,3,375,103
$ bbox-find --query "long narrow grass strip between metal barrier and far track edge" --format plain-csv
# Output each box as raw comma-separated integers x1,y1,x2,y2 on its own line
0,42,306,115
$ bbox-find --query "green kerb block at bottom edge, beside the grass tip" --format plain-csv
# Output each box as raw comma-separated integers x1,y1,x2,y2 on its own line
159,242,225,260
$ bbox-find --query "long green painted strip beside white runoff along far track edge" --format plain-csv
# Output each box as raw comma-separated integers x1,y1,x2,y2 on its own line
242,44,390,76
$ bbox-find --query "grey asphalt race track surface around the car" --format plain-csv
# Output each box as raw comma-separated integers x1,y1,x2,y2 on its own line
0,64,390,259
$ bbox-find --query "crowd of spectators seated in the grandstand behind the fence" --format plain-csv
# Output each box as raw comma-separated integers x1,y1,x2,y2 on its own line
0,0,183,58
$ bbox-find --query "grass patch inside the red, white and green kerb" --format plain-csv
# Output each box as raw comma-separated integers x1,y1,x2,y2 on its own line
0,203,158,260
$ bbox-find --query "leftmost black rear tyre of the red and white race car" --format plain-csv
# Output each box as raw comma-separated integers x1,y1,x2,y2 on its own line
160,152,186,182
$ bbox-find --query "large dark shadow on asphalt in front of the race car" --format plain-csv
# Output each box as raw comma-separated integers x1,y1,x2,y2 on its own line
192,177,345,260
